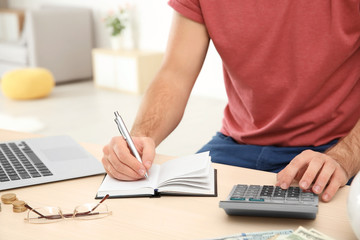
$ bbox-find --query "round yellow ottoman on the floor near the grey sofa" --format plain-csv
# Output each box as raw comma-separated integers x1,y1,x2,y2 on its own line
1,68,55,100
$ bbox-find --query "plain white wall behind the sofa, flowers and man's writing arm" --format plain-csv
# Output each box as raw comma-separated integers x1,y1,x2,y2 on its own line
8,0,226,99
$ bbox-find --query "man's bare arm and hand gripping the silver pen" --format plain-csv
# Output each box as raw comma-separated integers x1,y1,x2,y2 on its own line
102,12,210,180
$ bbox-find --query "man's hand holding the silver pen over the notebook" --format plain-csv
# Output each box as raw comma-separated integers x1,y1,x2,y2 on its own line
102,136,155,181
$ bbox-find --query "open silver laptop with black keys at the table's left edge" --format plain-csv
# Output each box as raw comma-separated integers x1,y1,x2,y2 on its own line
0,136,105,191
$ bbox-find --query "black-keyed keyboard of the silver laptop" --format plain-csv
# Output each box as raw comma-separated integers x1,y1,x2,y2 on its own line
0,142,53,182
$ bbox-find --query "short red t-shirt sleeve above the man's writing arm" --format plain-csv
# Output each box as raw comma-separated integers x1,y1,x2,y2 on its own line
168,0,204,23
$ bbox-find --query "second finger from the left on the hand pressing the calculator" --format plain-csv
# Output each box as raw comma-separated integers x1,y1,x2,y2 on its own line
299,155,325,189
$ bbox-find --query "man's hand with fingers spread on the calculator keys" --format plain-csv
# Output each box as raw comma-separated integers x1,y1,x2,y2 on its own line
276,150,349,202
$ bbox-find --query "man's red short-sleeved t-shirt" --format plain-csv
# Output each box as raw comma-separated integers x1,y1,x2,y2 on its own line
169,0,360,146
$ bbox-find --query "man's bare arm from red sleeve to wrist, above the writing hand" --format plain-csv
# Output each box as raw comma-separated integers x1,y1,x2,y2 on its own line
131,13,209,145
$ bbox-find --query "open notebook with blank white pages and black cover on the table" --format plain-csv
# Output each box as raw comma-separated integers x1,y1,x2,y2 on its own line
96,152,217,198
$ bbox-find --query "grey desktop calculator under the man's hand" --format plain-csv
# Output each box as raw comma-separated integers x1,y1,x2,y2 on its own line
219,184,319,219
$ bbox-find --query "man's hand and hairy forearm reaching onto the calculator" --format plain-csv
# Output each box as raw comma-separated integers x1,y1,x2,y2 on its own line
277,120,360,202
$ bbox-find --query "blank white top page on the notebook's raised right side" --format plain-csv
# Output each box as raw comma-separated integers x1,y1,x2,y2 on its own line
158,152,210,185
